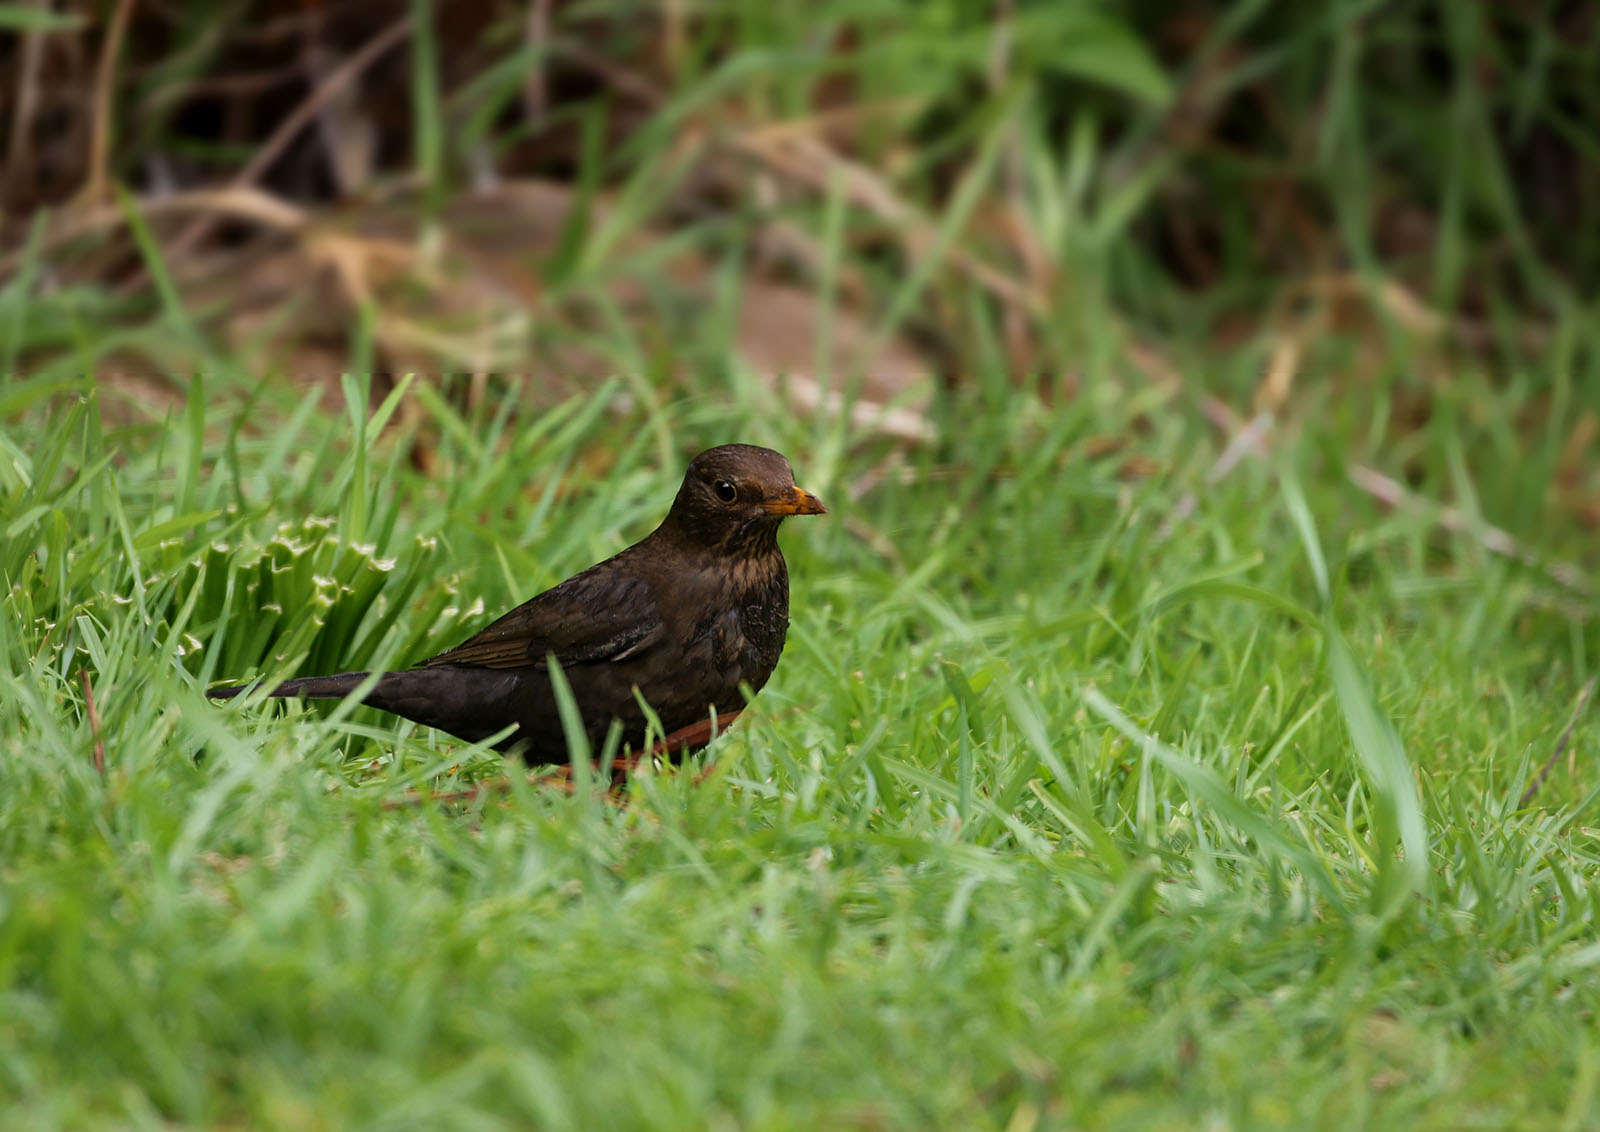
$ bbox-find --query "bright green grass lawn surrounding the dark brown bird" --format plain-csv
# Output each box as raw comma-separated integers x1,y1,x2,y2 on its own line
0,367,1600,1129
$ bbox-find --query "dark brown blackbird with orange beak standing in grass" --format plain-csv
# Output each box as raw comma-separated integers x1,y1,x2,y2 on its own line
206,444,827,763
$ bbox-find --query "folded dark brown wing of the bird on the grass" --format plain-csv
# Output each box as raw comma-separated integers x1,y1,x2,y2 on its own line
422,563,662,668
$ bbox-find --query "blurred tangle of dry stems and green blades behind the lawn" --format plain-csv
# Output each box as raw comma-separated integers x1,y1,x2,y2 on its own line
0,0,1600,388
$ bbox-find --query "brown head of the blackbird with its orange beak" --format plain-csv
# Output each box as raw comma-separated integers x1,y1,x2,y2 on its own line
666,444,827,550
